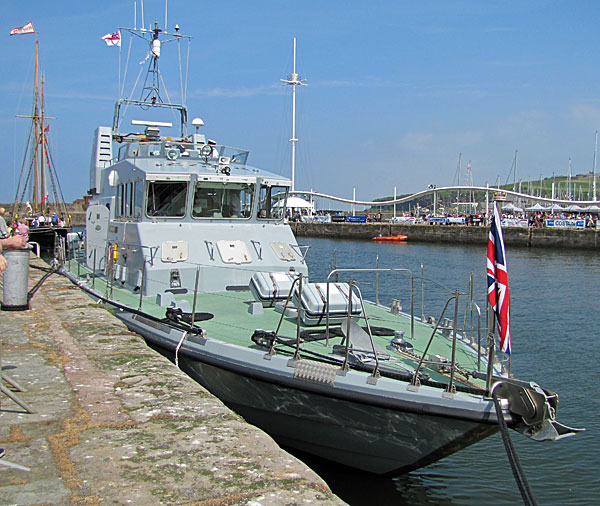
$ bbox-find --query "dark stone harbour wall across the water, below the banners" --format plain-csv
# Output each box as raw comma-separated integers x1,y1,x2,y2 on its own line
290,221,600,250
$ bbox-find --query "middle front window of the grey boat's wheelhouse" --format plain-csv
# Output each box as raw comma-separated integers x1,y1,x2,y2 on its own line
192,181,254,219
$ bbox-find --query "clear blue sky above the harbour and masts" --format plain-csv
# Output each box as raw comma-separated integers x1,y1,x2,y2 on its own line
0,0,600,202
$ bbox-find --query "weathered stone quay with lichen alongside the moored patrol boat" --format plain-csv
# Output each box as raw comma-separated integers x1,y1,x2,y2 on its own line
0,260,344,506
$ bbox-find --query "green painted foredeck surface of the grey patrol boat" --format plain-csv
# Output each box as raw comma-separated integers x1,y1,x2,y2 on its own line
68,265,486,387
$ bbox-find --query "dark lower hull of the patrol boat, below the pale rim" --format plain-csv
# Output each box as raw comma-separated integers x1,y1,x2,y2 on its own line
179,359,497,476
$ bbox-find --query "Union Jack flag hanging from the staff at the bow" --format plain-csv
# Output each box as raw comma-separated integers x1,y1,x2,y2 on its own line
487,205,511,355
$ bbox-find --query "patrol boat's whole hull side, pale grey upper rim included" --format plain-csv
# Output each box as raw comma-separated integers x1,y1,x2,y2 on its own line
117,312,498,476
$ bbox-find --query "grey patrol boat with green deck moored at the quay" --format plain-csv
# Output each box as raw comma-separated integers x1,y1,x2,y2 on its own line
58,18,573,476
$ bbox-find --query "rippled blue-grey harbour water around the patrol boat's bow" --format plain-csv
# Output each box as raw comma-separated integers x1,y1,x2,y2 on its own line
299,238,600,505
